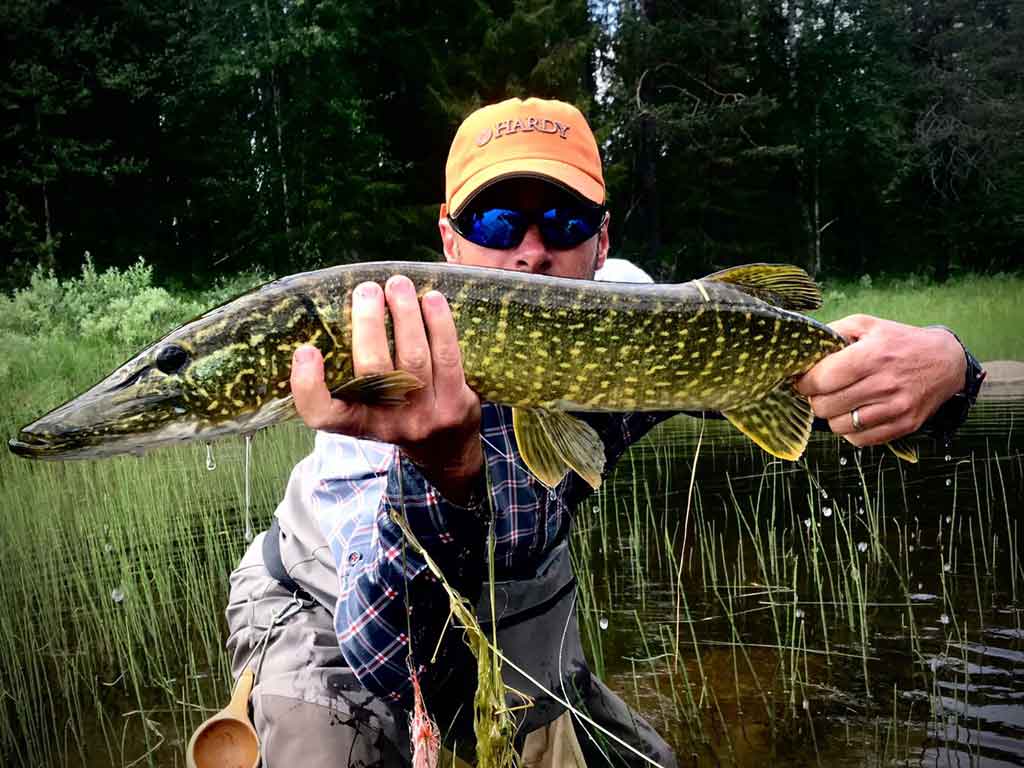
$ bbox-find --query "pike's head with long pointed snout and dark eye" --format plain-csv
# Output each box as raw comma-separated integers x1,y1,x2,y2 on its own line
8,289,321,460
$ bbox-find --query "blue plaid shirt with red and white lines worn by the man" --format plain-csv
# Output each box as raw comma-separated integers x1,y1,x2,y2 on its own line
309,402,669,702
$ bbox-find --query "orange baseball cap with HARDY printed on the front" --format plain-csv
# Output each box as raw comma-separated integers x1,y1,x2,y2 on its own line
444,98,604,216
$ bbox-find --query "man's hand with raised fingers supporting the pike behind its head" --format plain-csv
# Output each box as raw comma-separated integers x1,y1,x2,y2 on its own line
292,275,483,503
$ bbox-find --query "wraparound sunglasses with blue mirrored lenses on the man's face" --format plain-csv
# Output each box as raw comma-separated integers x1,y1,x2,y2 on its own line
450,205,605,251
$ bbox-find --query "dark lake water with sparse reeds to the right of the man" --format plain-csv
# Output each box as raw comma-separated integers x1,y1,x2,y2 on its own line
574,400,1024,767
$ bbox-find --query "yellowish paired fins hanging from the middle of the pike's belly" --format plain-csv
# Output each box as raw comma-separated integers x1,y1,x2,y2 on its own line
512,408,604,488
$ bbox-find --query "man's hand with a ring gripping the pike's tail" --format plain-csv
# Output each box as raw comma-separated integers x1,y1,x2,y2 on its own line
797,314,967,445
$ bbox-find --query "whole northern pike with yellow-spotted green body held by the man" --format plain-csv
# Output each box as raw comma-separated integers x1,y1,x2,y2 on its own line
9,262,913,487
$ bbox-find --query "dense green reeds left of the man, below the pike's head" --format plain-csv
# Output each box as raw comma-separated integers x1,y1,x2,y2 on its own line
0,429,310,765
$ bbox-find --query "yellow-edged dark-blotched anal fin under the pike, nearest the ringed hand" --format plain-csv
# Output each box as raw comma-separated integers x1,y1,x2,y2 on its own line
722,381,814,461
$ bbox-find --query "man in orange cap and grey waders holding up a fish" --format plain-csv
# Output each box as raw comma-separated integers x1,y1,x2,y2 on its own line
227,99,983,768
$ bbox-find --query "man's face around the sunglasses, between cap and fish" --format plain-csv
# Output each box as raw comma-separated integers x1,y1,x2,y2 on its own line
437,179,608,280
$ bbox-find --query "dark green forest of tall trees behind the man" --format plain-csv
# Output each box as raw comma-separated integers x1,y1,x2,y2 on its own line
0,0,1024,292
